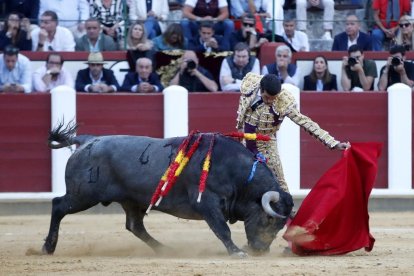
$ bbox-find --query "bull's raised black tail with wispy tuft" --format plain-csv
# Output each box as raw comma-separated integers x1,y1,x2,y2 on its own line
47,122,94,149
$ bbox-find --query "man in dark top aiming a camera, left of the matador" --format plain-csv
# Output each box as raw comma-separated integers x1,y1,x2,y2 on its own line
170,51,218,92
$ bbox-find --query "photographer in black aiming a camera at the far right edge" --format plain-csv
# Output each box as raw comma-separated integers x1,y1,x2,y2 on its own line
378,45,414,91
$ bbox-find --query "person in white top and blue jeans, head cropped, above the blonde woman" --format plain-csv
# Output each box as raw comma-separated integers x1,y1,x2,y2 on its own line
129,0,170,39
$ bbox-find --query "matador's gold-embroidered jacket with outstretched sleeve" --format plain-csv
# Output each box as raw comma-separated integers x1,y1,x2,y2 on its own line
237,73,339,149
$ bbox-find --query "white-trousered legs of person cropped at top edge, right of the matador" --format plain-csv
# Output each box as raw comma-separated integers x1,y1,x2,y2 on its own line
296,0,334,40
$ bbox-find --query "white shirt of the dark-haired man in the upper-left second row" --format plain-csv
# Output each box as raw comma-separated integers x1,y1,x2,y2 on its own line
32,26,76,52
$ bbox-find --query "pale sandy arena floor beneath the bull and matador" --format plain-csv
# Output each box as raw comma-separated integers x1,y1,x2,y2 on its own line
0,212,414,276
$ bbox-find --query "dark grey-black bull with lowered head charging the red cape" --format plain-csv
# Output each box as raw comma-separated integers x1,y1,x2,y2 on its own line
43,127,293,256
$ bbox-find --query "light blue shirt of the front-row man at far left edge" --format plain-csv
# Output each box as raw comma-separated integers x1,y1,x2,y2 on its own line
0,54,32,93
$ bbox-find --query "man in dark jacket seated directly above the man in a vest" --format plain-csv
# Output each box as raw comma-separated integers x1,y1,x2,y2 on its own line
230,14,269,51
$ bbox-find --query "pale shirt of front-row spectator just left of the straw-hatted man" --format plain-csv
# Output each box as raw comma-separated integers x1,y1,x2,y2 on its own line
33,66,75,92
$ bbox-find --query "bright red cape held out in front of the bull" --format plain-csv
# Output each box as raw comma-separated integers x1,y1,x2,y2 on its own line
283,143,382,255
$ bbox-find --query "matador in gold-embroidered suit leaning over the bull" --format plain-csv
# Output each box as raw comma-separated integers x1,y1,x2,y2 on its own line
237,73,350,192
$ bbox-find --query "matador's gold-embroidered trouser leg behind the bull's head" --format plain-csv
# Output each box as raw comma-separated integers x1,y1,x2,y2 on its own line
256,139,289,193
